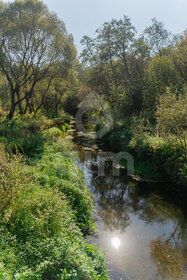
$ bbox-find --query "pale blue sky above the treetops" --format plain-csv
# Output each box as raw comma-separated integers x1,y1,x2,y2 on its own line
7,0,187,52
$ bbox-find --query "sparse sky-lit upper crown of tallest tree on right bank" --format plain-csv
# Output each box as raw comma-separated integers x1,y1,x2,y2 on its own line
81,16,136,83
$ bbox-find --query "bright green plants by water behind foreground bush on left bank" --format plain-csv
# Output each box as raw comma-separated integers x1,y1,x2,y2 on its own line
33,138,93,234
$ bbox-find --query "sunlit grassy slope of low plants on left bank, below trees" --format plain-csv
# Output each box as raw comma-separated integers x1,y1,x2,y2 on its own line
0,115,108,280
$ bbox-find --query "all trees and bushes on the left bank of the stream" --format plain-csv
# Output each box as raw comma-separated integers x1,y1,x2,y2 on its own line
0,0,108,280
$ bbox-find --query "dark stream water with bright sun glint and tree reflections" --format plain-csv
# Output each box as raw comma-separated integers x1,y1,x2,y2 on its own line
73,132,187,280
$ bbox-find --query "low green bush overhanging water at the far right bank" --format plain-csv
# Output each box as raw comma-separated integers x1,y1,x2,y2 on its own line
130,135,187,185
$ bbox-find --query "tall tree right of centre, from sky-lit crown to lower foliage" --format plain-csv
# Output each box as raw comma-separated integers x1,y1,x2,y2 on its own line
81,16,149,113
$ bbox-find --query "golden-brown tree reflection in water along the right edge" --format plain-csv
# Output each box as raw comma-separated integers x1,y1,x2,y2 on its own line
148,196,187,280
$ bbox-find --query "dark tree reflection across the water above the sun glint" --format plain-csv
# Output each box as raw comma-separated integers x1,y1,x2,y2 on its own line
91,173,186,234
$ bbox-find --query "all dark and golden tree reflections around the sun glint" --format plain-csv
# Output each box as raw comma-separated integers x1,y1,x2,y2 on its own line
85,155,187,280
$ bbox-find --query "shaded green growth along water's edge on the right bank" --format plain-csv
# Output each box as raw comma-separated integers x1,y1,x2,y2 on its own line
102,118,187,186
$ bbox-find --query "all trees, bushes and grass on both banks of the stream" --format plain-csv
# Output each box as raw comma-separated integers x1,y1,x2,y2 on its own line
0,0,187,280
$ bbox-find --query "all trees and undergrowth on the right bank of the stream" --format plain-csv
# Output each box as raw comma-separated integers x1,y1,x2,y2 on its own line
81,16,187,184
